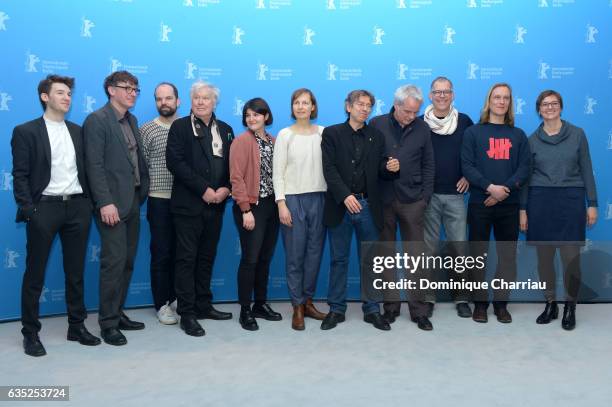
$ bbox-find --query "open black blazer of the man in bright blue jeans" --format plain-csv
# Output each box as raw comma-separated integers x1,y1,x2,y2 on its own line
321,122,395,229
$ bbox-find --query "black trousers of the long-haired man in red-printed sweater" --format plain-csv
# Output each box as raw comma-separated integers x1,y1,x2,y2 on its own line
468,203,519,306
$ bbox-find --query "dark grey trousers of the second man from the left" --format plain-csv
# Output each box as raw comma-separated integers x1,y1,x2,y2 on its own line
95,191,140,329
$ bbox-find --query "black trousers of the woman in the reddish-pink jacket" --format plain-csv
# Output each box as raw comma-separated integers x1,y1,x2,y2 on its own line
232,196,280,306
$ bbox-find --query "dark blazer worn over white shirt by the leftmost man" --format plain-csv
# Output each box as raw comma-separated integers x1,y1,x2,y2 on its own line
11,117,89,222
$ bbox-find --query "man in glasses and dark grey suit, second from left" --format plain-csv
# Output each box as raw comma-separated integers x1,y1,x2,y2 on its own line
83,71,149,346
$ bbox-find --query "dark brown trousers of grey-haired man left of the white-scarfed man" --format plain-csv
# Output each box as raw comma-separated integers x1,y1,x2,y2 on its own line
380,199,428,318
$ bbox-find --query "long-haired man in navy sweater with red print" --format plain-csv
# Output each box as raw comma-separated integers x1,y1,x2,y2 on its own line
461,83,529,323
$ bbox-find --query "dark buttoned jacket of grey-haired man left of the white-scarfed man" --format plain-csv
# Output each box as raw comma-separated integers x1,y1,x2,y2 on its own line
370,113,435,205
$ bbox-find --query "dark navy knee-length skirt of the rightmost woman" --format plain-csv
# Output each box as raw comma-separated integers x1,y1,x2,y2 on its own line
527,187,586,245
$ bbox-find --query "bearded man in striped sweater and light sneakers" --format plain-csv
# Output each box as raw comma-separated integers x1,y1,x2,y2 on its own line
140,82,180,325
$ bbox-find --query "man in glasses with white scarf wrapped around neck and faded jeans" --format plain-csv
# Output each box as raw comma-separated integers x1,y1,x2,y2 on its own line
421,76,474,318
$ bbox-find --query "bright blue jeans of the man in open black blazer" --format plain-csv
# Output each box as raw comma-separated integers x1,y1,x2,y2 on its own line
327,199,380,314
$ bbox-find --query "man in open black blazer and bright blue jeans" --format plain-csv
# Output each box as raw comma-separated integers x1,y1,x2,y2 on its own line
321,90,399,331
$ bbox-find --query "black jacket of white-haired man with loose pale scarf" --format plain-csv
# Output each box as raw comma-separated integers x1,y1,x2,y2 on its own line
166,115,234,216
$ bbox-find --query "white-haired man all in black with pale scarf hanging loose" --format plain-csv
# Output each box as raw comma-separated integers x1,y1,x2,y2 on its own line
166,81,234,336
